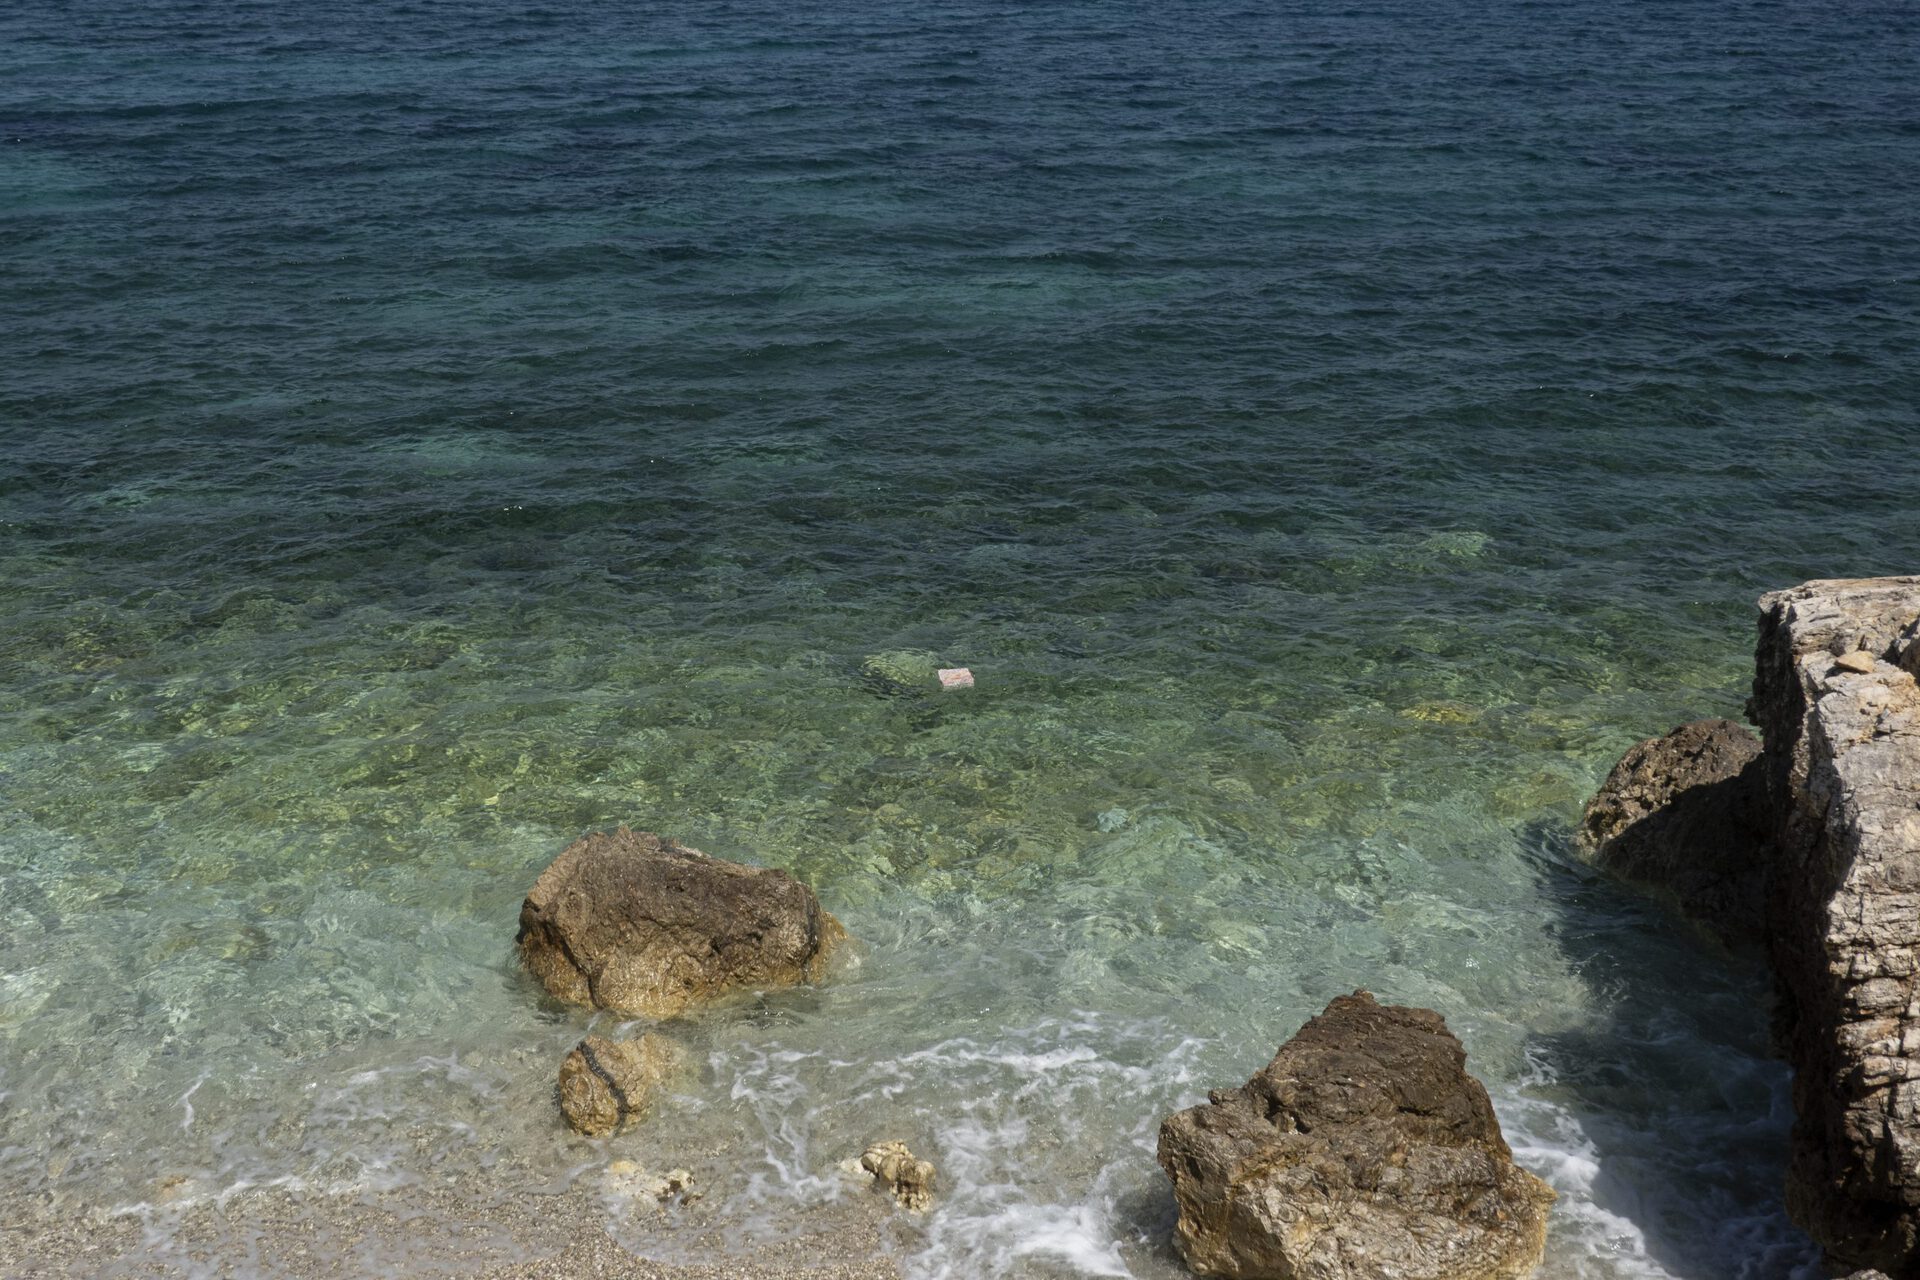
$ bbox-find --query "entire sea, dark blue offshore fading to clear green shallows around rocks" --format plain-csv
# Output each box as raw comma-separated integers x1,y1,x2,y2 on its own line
0,0,1920,1278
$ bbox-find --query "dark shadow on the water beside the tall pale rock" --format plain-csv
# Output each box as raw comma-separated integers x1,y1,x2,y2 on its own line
1507,823,1824,1280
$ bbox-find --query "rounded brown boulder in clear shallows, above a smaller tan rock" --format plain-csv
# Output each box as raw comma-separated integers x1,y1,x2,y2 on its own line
518,827,847,1017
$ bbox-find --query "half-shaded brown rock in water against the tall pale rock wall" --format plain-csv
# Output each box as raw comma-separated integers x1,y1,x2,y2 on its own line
1580,720,1772,940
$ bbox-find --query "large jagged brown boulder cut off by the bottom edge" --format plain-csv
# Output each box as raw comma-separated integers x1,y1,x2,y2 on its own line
1160,992,1553,1280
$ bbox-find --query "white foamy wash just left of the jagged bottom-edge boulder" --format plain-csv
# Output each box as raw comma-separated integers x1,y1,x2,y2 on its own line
691,1013,1202,1280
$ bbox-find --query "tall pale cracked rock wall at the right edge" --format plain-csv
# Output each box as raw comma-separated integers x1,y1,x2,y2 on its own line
1749,578,1920,1280
